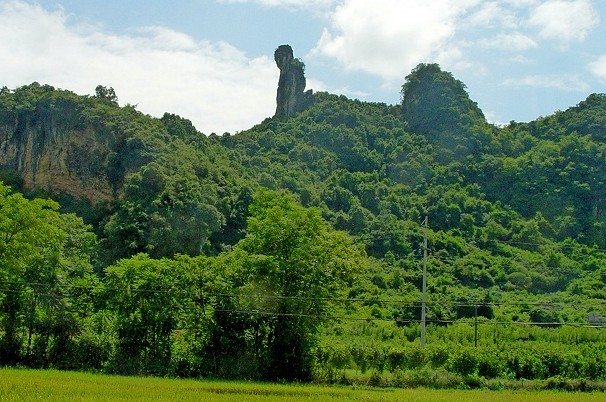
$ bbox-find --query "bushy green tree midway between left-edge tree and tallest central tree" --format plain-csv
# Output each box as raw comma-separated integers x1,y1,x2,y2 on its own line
103,254,183,374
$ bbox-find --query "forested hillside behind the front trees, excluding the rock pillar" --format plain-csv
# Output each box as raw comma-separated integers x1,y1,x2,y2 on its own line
0,64,606,312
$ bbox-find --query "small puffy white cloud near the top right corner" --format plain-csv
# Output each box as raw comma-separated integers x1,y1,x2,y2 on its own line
528,0,600,45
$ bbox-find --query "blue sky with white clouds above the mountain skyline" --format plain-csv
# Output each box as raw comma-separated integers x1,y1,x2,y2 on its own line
0,0,606,135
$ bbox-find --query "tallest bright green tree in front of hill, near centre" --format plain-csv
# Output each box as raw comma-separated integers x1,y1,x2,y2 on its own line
214,191,365,380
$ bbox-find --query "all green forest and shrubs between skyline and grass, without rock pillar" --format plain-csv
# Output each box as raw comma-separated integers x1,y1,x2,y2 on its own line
0,64,606,385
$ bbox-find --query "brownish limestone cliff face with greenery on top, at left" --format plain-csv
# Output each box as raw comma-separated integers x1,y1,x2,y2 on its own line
0,83,128,204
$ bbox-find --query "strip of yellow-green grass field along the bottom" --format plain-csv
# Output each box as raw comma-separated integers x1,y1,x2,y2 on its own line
0,369,605,402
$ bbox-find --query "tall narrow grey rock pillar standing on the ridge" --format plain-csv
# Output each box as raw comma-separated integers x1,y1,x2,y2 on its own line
274,45,313,119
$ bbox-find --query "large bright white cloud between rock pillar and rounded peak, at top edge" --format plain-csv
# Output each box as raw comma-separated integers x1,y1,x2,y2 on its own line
312,0,479,80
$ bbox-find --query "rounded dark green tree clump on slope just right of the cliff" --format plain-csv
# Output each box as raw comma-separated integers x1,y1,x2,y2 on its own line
105,162,223,260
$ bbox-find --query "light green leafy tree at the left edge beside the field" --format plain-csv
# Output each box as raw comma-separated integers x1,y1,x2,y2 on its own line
0,184,95,365
